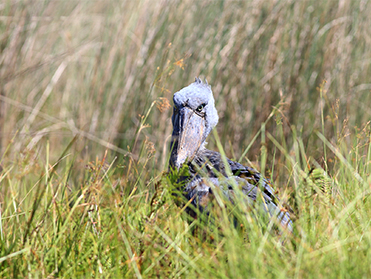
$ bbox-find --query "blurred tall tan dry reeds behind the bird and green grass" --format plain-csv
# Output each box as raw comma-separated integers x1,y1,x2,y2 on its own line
0,0,371,182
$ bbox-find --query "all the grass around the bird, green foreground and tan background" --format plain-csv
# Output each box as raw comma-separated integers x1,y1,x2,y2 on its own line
0,0,371,278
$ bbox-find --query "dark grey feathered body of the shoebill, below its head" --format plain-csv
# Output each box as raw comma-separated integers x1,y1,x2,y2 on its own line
185,148,292,231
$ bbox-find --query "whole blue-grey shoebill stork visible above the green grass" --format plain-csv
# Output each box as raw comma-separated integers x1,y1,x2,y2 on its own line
170,78,292,231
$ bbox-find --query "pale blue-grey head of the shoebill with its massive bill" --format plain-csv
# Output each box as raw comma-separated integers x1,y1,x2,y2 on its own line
170,78,219,168
